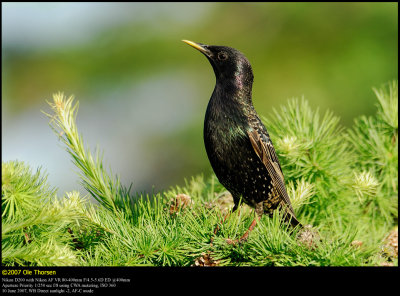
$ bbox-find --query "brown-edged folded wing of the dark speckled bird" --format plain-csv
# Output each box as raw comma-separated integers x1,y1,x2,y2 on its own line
247,129,296,217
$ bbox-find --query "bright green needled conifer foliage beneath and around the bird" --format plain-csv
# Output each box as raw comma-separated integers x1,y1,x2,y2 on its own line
2,82,398,266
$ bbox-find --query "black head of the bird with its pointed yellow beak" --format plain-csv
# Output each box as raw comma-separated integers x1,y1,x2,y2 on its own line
182,40,253,87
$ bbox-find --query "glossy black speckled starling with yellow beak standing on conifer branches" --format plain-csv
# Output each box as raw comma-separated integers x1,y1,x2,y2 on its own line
182,40,301,241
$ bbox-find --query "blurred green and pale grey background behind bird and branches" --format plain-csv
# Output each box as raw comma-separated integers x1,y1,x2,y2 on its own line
2,2,398,195
